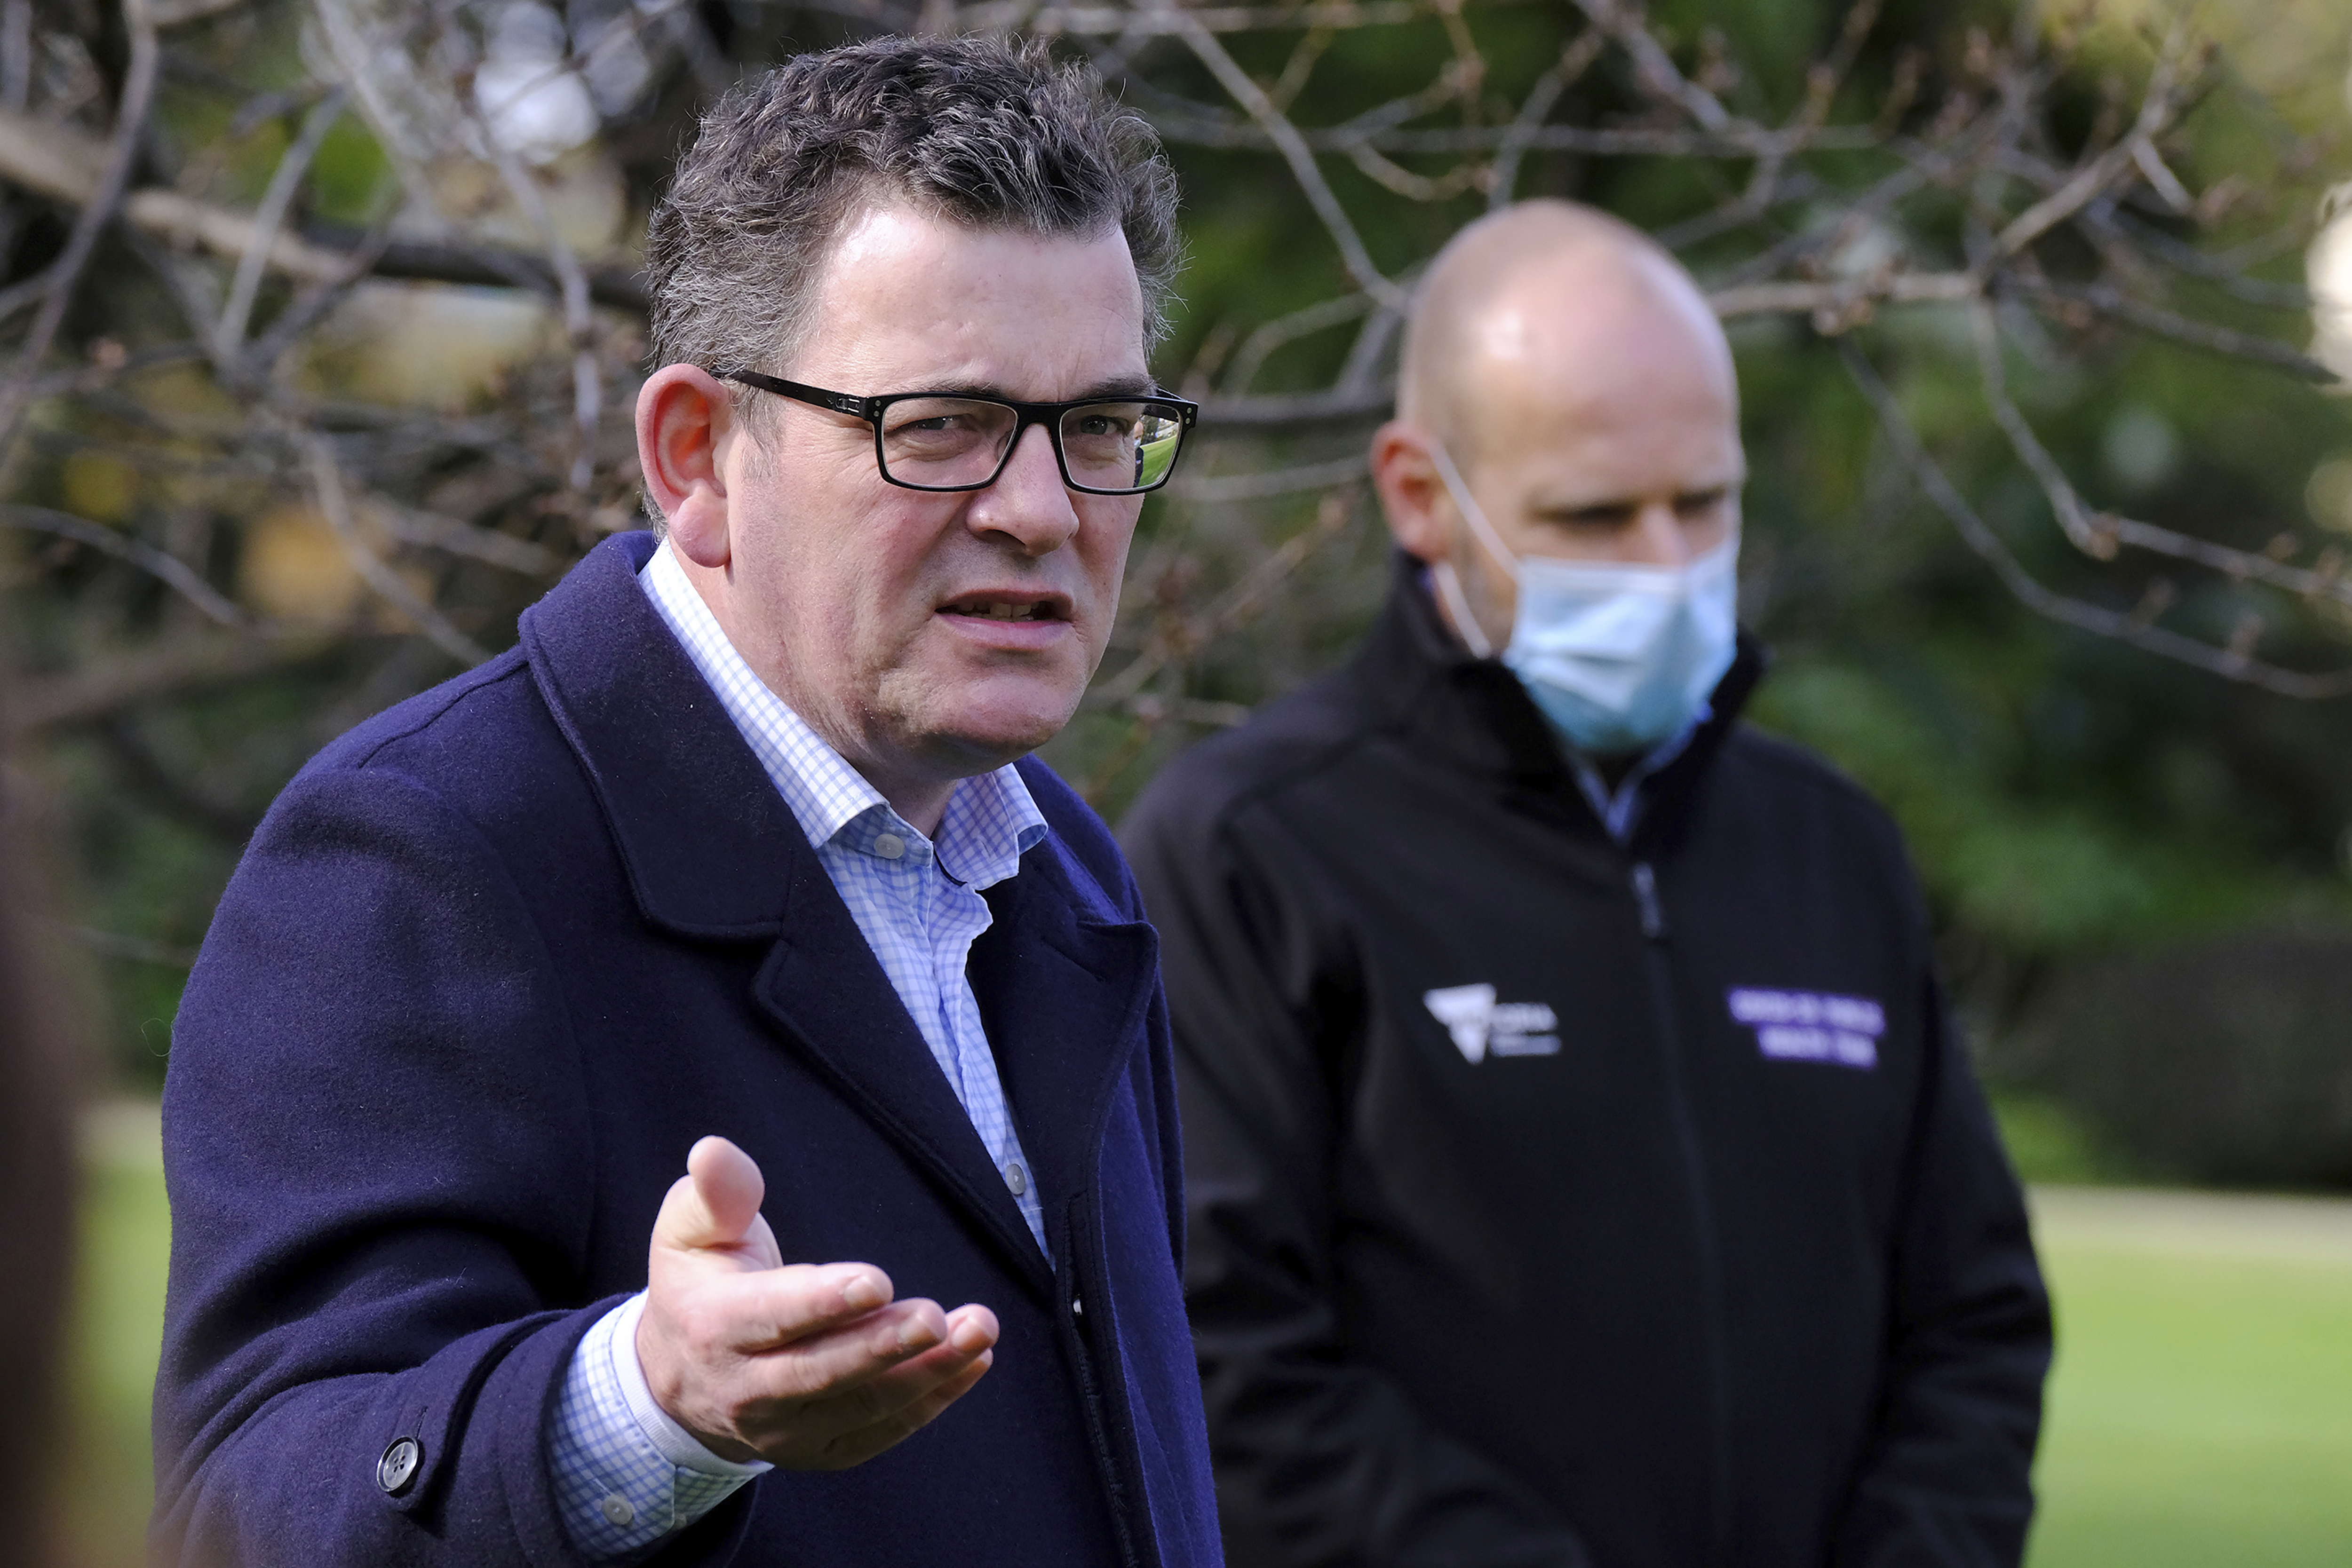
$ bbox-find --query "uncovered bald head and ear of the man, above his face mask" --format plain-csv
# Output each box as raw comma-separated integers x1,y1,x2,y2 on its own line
1371,202,1748,647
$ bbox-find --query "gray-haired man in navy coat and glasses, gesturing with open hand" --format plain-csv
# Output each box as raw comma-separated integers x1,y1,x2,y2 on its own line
155,40,1218,1568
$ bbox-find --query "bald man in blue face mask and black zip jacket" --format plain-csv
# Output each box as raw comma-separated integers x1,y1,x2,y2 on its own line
1122,202,2051,1568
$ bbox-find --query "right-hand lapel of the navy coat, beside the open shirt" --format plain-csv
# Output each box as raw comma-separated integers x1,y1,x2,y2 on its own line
971,837,1160,1241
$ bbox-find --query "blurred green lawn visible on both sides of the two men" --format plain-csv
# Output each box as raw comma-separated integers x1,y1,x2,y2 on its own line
50,1107,2352,1568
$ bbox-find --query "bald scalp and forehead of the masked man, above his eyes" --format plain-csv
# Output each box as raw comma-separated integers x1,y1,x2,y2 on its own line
1397,200,1738,466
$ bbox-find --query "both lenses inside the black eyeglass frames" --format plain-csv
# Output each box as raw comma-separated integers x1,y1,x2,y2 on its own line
882,397,1183,494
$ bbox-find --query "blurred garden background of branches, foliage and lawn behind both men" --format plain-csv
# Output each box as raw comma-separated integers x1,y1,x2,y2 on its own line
0,0,2352,1568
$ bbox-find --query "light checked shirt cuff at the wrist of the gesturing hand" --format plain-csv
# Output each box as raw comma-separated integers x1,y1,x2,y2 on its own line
546,1293,769,1563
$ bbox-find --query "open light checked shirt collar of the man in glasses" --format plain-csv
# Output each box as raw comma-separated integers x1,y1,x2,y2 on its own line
637,543,1044,888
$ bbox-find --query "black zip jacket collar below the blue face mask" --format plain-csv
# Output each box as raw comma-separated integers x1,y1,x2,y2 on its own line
1352,550,1771,848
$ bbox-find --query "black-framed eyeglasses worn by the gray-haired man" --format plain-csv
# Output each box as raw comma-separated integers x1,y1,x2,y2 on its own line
713,369,1200,496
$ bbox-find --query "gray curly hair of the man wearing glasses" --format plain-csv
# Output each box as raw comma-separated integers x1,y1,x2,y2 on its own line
644,38,1181,390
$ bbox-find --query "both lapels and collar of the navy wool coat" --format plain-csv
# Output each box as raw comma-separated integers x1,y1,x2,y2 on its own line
522,534,1157,1291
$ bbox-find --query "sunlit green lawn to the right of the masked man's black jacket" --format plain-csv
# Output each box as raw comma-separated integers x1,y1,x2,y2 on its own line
2030,1187,2352,1568
